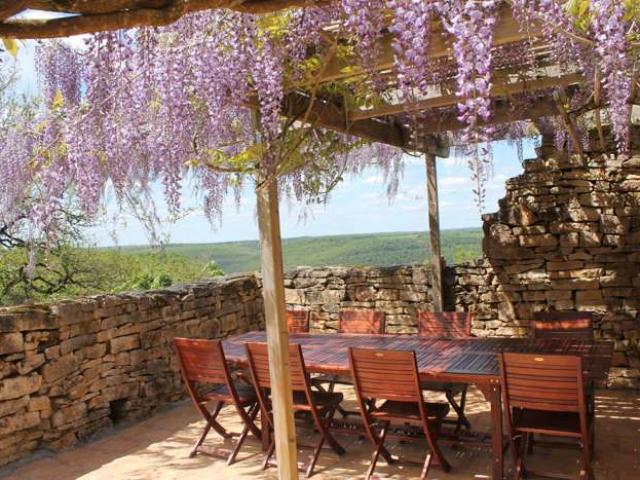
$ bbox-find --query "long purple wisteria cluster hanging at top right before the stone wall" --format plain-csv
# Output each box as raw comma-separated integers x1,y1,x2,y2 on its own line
589,0,631,152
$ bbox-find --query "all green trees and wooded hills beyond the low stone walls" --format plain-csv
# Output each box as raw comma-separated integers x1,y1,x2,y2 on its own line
0,229,482,306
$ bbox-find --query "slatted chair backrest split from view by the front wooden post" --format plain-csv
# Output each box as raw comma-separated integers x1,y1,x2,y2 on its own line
246,343,310,391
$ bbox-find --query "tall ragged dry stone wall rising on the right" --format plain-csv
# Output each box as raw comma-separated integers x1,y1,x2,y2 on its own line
480,146,640,388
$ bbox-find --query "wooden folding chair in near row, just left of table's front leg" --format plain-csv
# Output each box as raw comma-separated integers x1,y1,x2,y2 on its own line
349,348,451,480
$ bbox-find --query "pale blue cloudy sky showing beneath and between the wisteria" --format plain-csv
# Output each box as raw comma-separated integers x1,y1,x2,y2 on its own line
7,29,533,245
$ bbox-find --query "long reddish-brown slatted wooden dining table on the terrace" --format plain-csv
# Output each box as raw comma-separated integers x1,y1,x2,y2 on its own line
223,331,613,480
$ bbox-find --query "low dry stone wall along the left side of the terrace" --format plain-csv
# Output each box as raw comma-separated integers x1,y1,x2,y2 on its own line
0,275,264,466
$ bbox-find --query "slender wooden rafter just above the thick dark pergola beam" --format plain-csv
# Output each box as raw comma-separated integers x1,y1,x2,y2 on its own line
349,73,583,122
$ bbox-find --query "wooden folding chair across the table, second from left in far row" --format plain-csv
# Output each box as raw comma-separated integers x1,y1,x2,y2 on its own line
313,310,384,418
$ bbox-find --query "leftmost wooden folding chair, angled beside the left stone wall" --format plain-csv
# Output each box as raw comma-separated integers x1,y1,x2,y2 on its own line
173,338,262,465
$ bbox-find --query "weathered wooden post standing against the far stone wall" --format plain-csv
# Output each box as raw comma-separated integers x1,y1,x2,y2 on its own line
425,153,444,312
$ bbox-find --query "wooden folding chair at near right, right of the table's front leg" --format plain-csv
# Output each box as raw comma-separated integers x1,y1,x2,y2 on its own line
500,353,594,480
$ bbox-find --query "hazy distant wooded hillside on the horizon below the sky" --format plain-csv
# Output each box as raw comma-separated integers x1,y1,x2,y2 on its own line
117,228,482,273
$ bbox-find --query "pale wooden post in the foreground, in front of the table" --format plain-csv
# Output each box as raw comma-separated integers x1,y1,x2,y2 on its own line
256,178,298,480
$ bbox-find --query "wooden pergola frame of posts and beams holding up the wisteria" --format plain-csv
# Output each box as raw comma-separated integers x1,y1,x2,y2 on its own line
0,0,637,480
